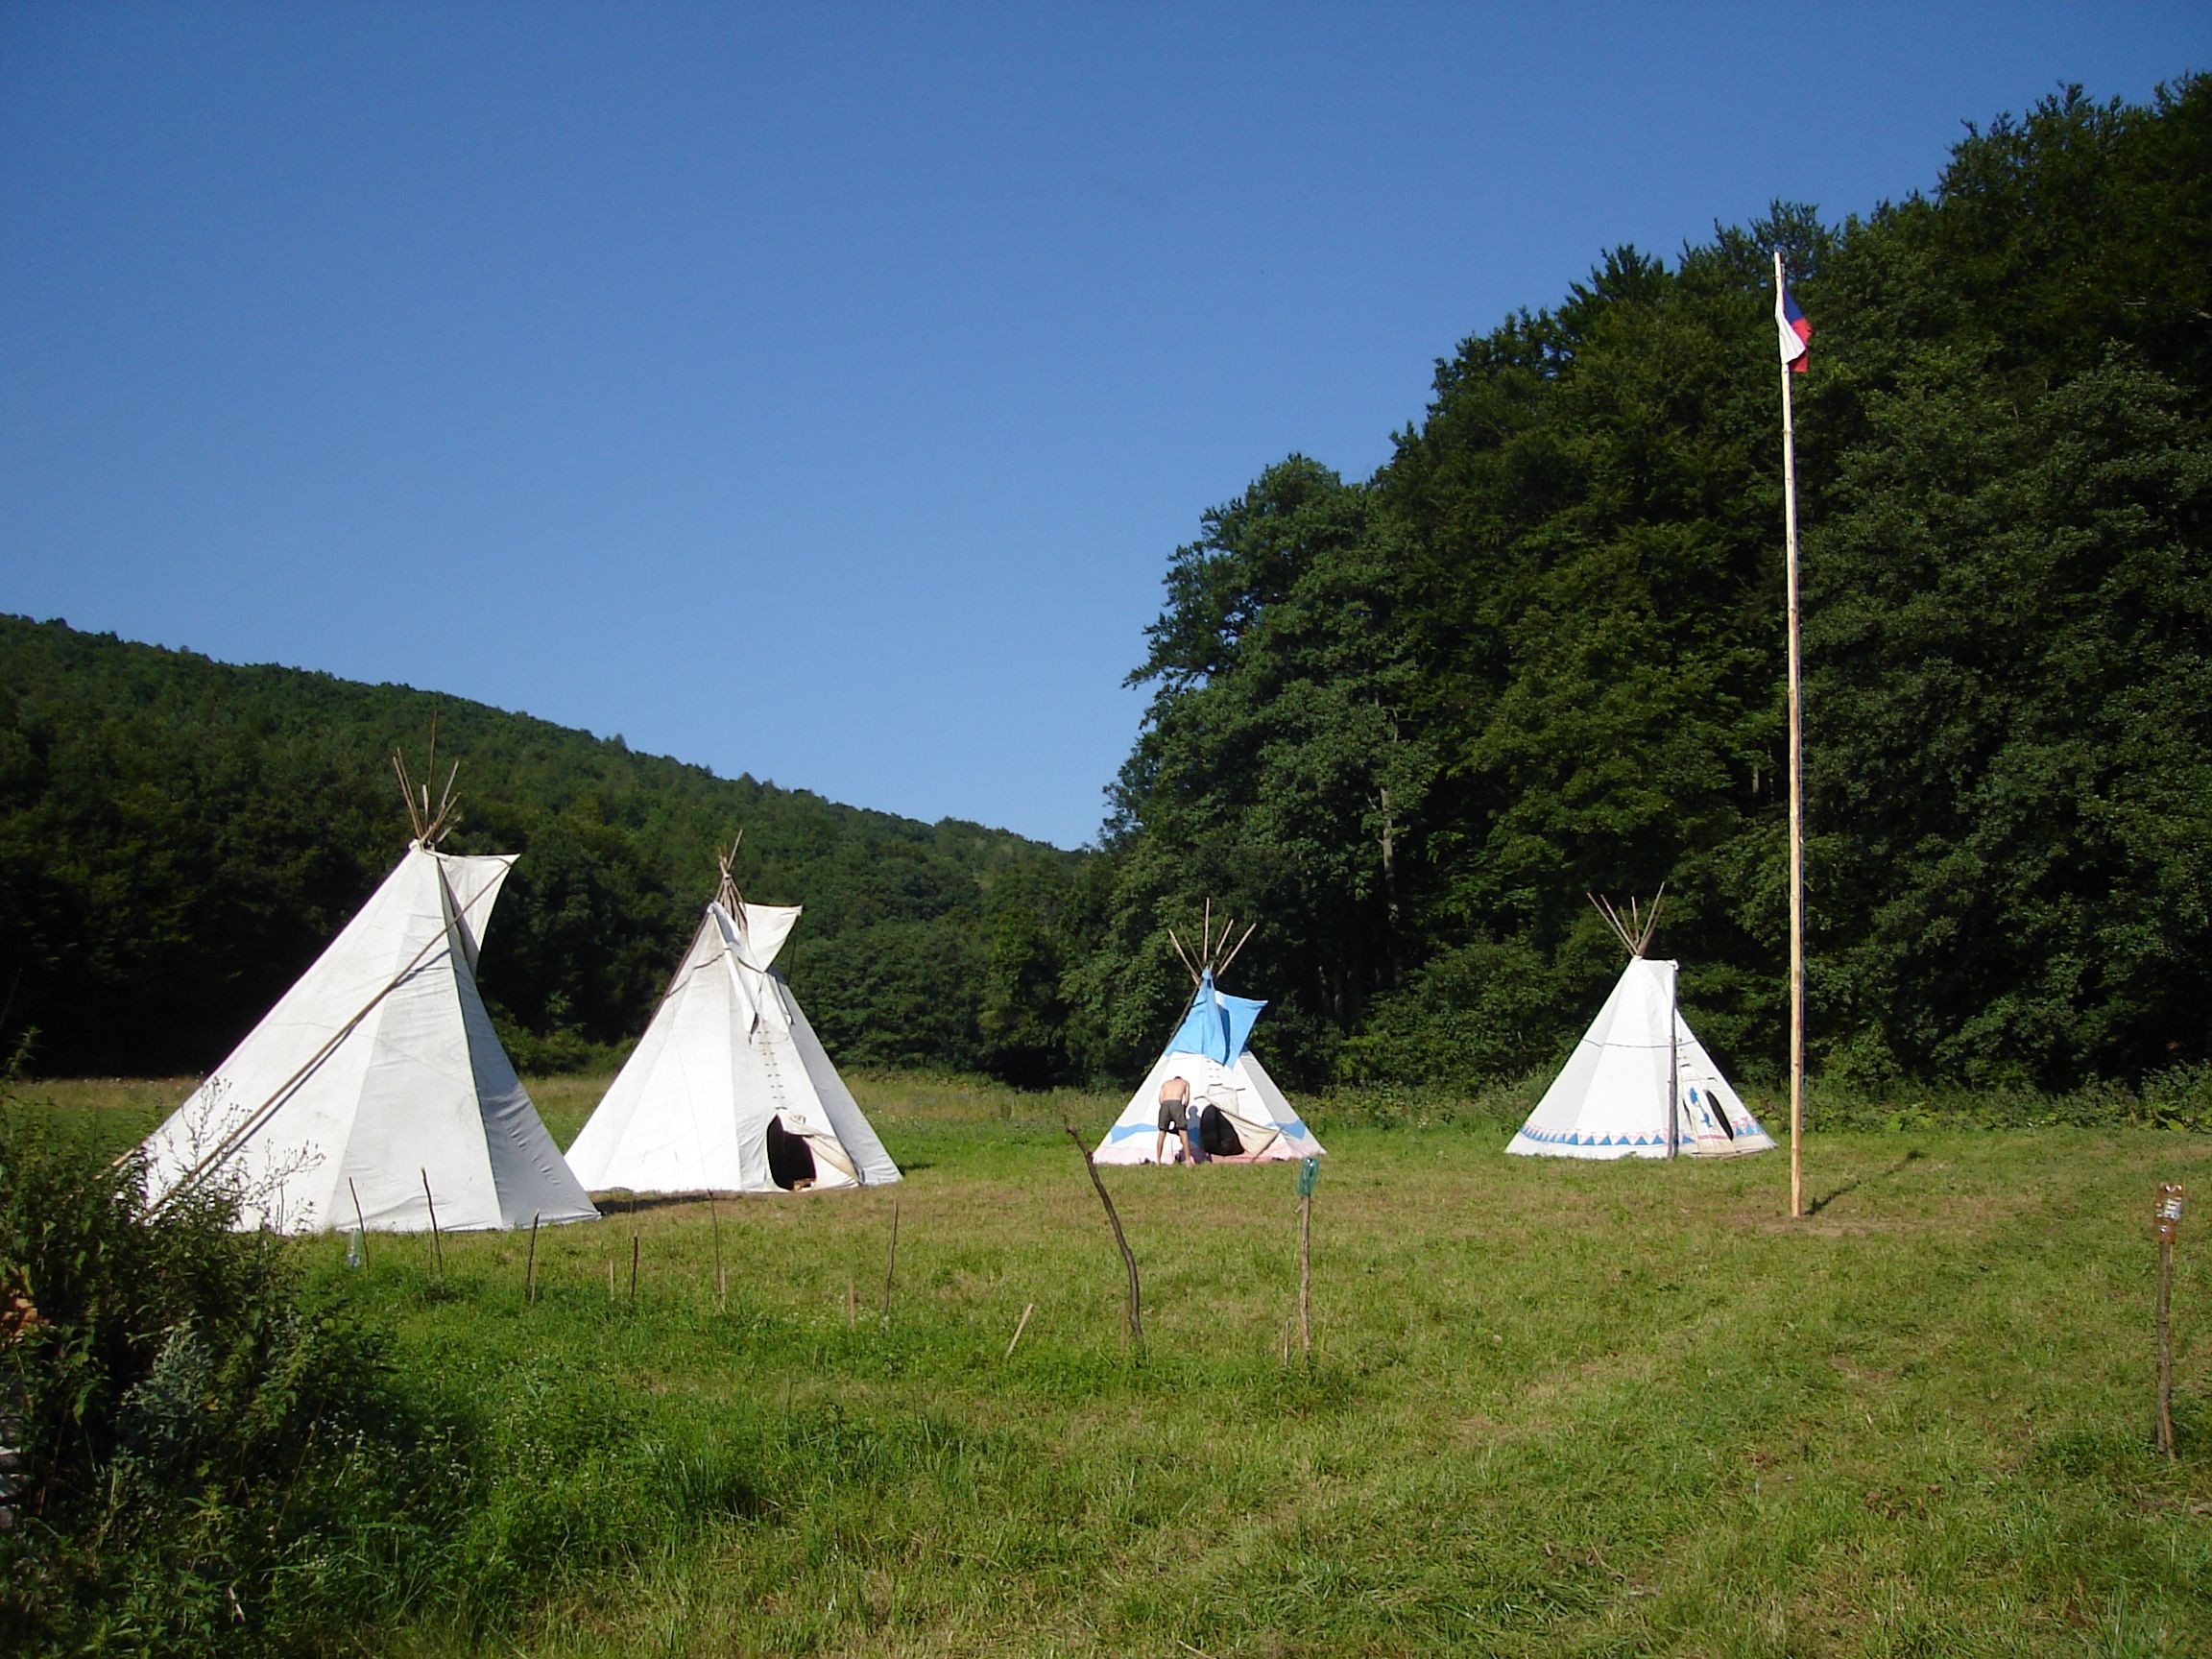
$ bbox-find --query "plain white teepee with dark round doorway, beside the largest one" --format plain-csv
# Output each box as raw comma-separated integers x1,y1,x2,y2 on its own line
568,845,898,1192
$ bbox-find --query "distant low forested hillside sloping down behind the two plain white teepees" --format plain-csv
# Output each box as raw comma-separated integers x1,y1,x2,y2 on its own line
0,617,1070,1075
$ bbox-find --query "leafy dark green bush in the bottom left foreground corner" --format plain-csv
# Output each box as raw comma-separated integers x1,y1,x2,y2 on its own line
0,1097,471,1654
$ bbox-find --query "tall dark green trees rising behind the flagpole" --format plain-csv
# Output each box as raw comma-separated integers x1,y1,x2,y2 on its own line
1082,78,2212,1086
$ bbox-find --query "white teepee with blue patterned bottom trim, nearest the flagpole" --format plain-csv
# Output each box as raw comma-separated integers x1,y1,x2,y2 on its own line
1506,894,1774,1157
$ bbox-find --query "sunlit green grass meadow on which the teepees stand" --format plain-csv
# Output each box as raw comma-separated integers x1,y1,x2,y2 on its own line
53,1079,2212,1659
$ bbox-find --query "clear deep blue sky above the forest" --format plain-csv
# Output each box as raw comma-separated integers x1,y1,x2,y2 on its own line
0,0,2212,845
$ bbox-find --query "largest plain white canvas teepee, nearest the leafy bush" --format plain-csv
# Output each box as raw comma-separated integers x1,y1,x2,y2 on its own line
144,757,597,1232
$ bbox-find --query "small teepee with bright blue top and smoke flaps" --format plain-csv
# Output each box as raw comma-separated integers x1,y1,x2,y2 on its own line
1091,904,1323,1164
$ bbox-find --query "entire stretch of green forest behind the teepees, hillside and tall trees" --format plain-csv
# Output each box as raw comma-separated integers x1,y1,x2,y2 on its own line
0,78,2212,1086
